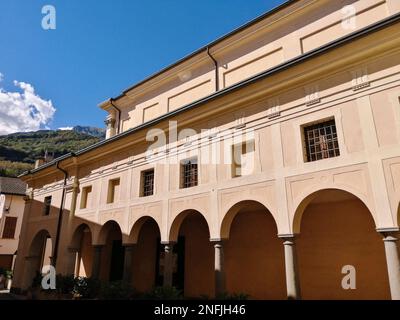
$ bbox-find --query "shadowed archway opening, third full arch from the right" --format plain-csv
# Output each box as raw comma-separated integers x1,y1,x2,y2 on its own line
172,210,214,297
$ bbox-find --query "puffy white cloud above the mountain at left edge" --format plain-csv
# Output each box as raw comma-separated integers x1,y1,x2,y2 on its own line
0,75,56,135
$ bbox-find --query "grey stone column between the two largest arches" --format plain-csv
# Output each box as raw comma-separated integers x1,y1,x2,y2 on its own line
280,235,301,300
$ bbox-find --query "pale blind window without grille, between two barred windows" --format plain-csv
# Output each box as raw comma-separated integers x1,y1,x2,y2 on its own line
232,140,255,177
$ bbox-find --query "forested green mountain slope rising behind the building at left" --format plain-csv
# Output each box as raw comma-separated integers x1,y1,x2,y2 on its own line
0,126,104,177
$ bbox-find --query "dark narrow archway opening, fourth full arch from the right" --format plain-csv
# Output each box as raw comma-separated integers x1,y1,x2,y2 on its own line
131,217,162,292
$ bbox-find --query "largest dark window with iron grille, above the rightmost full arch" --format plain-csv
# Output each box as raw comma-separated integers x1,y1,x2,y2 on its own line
304,120,340,162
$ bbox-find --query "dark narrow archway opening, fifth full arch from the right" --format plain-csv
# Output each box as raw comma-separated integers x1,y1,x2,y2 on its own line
100,221,125,281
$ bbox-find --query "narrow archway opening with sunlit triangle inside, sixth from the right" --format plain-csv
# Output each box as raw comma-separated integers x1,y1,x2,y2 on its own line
71,224,93,277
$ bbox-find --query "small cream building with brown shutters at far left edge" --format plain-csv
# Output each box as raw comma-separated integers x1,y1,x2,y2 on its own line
0,177,27,270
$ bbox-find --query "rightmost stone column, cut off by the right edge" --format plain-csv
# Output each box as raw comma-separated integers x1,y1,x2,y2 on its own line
378,229,400,300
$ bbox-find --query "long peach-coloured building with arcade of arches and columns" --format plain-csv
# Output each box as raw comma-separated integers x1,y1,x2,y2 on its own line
13,0,400,299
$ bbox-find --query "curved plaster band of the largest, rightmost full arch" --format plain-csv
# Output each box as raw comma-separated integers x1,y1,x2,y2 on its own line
292,186,378,234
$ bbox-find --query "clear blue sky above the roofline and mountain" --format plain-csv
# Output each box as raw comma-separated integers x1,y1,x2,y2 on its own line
0,0,284,133
